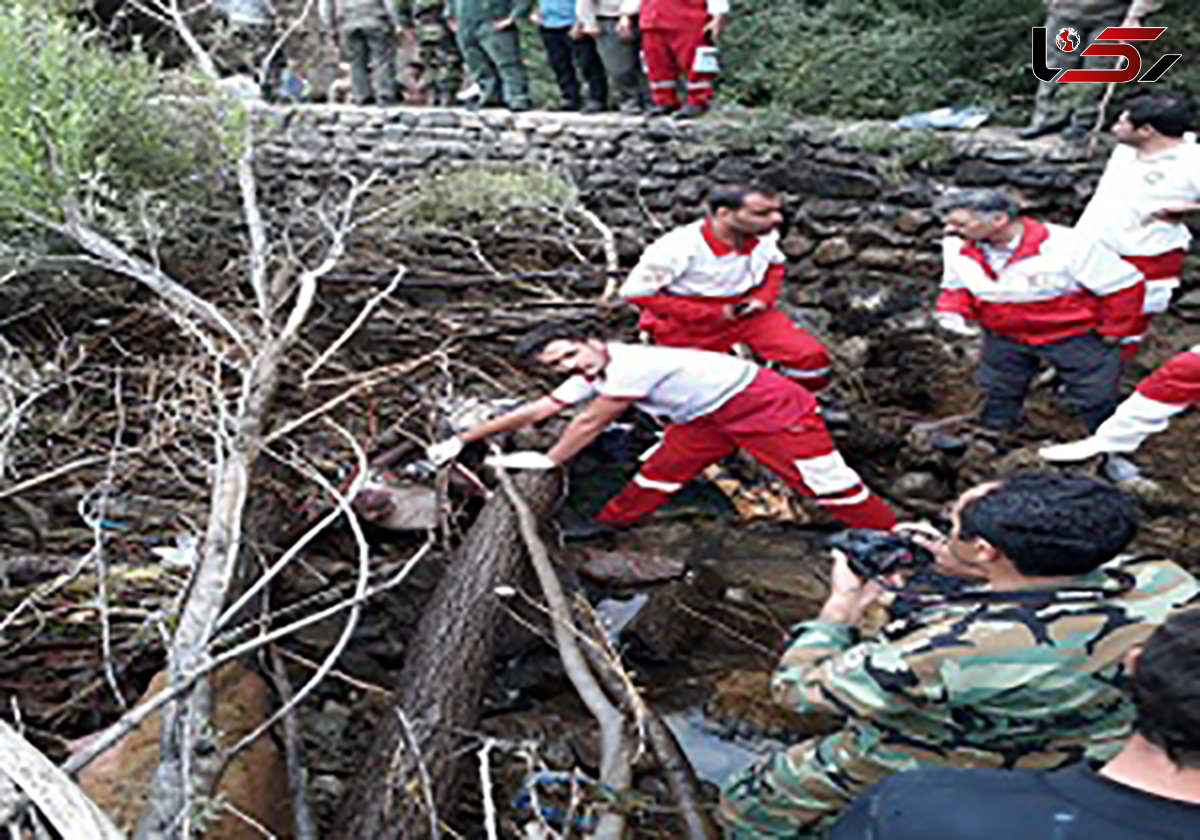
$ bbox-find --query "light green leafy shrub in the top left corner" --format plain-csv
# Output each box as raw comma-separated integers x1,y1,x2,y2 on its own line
0,0,228,240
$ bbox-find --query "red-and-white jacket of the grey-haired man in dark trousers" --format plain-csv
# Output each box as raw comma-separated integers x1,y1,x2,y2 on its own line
936,218,1145,344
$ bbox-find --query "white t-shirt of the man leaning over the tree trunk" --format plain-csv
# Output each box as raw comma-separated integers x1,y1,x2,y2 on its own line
550,342,758,422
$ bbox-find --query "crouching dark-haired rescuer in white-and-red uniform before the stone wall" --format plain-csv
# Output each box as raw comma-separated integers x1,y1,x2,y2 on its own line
619,186,829,390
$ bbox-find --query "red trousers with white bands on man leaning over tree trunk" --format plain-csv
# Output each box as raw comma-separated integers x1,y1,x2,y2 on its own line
596,371,896,528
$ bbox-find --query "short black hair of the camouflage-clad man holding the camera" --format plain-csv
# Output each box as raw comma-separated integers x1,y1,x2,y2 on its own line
959,472,1138,576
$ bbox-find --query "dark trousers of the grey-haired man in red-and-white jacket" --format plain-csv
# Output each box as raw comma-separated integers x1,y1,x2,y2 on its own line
978,332,1121,432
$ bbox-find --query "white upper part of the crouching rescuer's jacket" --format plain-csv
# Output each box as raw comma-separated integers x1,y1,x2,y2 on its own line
619,220,786,298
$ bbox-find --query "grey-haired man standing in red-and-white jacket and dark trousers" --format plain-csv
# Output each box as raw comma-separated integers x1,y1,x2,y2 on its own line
936,191,1146,433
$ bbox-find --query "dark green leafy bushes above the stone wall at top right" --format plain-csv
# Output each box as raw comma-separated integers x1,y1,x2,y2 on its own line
721,0,1200,124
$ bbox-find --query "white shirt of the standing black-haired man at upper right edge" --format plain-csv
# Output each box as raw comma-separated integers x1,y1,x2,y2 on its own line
1075,138,1200,257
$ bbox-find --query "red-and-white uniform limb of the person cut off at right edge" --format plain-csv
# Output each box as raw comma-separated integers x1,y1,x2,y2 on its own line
1092,344,1200,452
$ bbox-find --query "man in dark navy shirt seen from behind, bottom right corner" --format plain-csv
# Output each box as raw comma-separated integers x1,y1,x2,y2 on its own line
829,608,1200,840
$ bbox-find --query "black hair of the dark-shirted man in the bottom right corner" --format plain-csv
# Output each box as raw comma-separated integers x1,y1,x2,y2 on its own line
1132,607,1200,768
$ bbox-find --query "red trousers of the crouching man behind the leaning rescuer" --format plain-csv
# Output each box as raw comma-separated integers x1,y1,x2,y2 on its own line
638,309,829,391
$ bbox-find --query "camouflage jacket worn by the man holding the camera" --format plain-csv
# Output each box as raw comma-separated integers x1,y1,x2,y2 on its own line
772,558,1200,767
